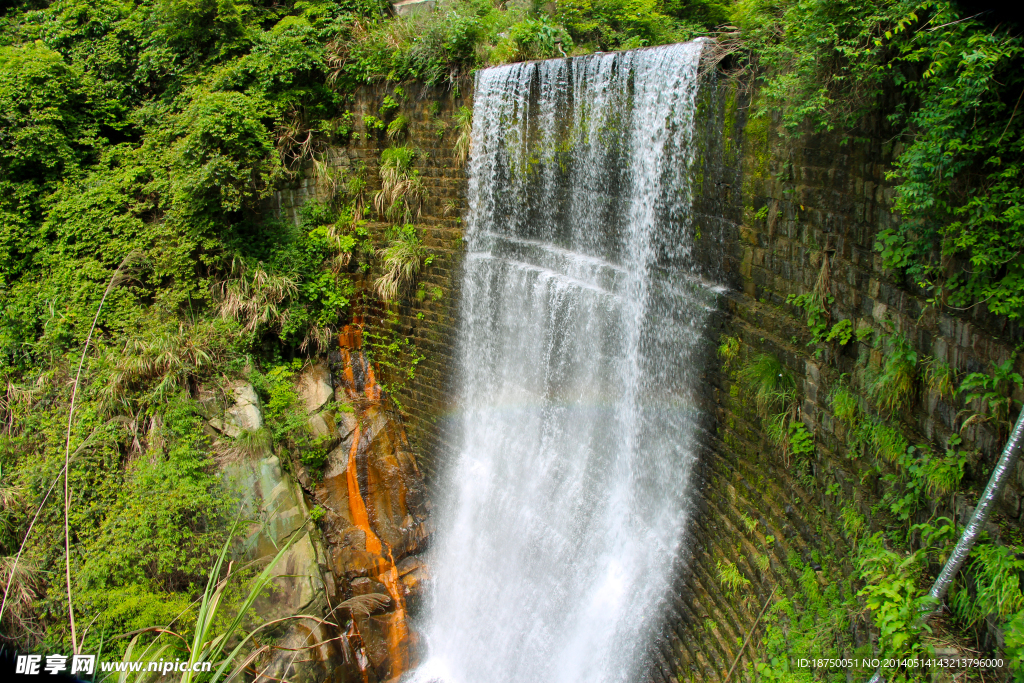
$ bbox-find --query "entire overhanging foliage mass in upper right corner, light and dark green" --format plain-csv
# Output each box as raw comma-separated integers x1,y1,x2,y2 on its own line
732,0,1024,318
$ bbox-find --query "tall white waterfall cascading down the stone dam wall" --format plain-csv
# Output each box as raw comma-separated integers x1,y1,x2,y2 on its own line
413,42,714,683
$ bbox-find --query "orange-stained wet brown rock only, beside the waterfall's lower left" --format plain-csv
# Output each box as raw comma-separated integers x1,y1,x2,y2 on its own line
300,331,430,682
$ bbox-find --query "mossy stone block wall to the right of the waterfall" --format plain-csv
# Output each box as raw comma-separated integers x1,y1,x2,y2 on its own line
648,76,1024,681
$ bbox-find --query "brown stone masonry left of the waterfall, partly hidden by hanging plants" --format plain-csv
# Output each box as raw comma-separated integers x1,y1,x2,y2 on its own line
270,81,472,477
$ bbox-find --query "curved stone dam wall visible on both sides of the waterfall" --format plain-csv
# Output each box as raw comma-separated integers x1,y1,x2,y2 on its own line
273,66,1024,682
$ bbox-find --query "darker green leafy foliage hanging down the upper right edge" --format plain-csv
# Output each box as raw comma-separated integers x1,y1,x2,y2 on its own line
879,8,1024,318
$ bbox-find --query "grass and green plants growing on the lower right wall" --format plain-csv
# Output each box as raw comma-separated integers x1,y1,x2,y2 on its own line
718,334,1024,681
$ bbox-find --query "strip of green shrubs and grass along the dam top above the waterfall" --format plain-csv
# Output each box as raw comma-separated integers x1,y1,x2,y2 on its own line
327,0,726,88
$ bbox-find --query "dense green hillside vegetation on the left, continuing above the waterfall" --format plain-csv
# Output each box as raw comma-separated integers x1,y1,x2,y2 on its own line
0,0,725,663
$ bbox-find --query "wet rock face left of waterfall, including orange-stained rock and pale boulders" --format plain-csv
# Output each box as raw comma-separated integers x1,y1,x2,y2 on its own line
207,328,431,683
